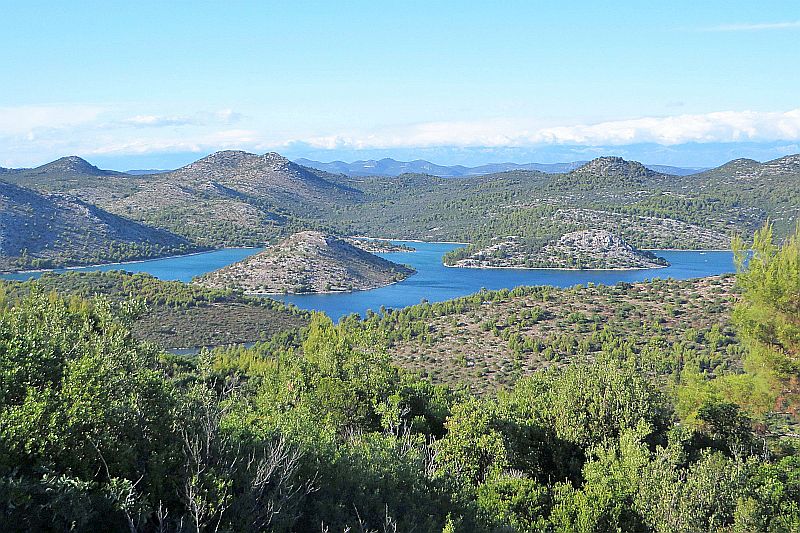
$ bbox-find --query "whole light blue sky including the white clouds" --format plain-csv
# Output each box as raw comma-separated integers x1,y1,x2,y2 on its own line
0,0,800,170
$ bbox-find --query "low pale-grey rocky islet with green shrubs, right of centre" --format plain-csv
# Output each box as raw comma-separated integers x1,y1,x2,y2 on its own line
444,230,669,270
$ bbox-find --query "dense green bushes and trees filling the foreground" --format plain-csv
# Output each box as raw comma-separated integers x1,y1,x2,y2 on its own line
0,222,800,533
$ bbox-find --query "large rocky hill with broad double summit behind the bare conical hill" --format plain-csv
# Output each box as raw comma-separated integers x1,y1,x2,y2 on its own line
101,150,362,246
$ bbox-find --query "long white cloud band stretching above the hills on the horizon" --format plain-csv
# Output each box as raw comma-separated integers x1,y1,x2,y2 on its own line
0,105,800,165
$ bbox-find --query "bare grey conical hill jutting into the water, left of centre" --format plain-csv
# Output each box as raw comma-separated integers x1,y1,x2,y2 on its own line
195,231,414,294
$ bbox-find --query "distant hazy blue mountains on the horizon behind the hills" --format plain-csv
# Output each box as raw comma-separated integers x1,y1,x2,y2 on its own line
295,158,705,178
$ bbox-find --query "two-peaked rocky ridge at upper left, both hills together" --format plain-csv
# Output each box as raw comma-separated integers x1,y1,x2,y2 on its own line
3,151,361,246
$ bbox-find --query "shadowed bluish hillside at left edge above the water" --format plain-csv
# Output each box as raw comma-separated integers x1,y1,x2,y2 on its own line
0,182,197,271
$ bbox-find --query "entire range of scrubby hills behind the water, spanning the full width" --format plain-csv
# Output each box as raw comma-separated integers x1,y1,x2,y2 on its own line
2,151,800,264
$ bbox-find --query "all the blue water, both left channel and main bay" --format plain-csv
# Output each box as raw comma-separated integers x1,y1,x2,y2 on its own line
2,241,734,320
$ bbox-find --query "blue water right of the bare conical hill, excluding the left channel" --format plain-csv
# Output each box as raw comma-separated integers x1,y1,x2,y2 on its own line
274,241,735,320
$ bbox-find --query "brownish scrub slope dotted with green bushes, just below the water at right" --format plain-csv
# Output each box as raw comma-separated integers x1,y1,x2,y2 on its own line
350,276,742,391
